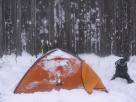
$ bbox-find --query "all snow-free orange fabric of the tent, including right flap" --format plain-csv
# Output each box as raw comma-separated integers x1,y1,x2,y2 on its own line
15,63,106,93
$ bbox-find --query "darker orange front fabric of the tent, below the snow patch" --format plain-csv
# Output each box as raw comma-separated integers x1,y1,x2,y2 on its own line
15,58,83,93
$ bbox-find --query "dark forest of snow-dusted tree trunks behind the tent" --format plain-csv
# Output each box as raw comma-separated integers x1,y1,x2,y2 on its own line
0,0,136,56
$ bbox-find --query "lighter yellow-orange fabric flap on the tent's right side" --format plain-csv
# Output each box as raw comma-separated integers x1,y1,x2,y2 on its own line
82,62,106,93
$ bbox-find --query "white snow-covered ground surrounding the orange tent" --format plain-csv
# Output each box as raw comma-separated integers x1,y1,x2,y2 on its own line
0,53,136,102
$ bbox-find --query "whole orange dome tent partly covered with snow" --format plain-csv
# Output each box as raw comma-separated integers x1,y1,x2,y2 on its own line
14,49,106,93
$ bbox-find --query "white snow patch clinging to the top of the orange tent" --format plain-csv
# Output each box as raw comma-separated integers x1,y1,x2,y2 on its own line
43,49,81,71
